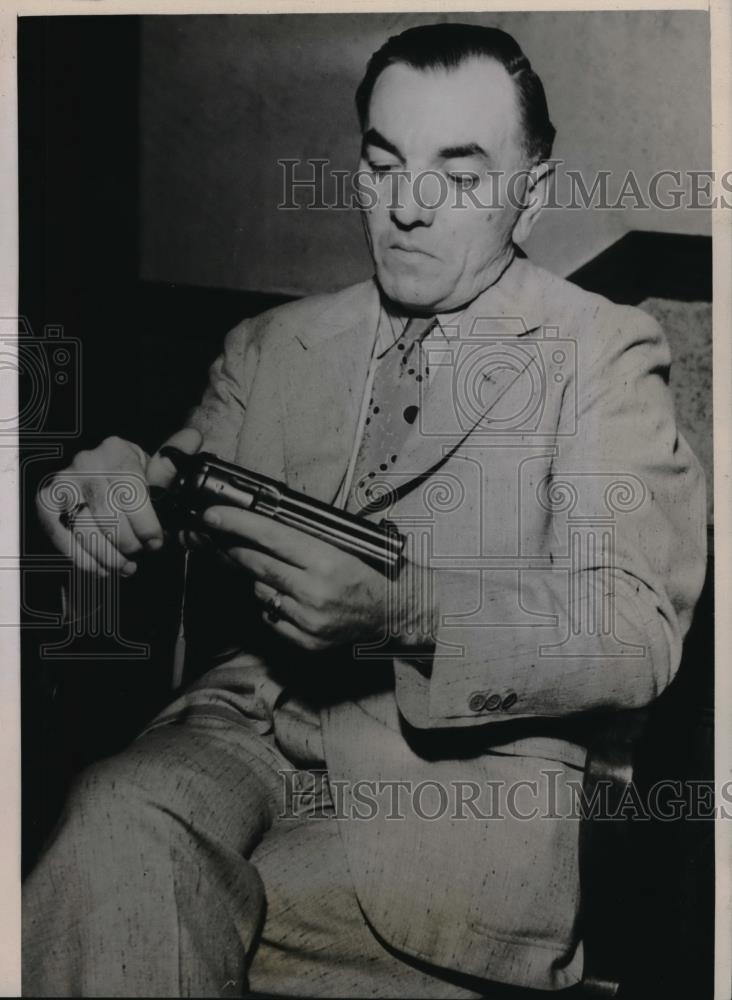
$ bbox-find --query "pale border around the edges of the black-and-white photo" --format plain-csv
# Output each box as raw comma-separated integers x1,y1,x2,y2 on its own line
0,0,732,1000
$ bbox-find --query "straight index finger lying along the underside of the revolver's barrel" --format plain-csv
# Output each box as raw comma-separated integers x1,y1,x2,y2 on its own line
203,507,338,571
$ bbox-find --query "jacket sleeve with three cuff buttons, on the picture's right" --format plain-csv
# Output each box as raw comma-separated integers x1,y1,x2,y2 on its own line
395,307,706,727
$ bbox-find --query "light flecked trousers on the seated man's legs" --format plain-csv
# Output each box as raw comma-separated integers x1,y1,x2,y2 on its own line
23,671,488,997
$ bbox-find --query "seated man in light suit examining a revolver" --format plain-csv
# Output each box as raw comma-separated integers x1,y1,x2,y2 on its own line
24,25,704,997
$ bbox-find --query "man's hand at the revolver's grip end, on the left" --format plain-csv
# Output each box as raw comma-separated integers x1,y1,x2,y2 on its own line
36,427,201,576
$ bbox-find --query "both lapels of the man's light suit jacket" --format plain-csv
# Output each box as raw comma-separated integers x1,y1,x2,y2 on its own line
279,258,542,502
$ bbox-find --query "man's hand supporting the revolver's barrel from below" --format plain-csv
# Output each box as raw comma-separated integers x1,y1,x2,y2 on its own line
204,507,432,651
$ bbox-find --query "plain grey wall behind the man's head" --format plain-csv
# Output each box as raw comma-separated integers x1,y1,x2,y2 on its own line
140,10,711,294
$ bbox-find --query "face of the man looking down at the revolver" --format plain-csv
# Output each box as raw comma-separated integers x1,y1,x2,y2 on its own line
360,58,526,312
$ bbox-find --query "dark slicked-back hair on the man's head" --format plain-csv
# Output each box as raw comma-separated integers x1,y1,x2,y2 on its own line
356,24,556,162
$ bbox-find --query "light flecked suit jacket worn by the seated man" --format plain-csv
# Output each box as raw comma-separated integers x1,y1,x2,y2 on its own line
186,259,705,989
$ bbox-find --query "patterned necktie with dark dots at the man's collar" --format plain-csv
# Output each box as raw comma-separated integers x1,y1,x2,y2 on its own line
349,316,437,510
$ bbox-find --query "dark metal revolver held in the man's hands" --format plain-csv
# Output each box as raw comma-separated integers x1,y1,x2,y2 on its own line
150,446,406,574
